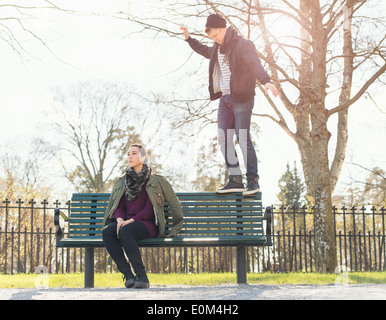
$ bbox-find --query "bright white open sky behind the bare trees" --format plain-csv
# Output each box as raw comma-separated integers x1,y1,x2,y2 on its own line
0,0,386,205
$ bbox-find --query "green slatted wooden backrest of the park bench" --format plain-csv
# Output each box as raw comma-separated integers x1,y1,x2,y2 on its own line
69,193,263,238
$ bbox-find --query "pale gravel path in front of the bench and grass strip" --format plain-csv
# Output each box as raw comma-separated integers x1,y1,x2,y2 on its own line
0,284,386,301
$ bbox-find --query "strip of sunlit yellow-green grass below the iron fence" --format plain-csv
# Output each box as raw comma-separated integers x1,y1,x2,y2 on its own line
0,272,386,288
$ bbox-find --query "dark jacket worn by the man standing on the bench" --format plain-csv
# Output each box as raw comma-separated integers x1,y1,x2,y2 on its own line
186,27,271,102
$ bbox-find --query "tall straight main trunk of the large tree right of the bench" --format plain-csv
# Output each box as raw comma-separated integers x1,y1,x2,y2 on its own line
310,6,337,273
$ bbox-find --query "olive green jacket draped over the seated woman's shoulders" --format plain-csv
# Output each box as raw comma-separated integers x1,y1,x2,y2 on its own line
103,174,184,238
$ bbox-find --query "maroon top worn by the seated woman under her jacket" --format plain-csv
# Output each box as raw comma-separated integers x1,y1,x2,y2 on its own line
114,185,158,238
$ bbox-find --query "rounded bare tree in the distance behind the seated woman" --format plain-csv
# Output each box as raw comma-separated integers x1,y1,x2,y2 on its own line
54,82,160,192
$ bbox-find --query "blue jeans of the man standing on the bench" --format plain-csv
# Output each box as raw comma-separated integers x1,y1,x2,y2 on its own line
217,95,257,176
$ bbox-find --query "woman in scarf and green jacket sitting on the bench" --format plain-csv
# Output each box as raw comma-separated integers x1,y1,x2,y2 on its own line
102,144,183,288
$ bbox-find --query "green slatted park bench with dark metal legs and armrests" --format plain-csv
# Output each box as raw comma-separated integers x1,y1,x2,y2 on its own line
54,193,272,288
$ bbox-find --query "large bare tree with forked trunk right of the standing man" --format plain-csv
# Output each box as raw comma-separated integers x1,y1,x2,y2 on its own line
117,0,386,272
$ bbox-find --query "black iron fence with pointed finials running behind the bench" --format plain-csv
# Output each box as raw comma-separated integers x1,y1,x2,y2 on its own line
0,199,386,274
